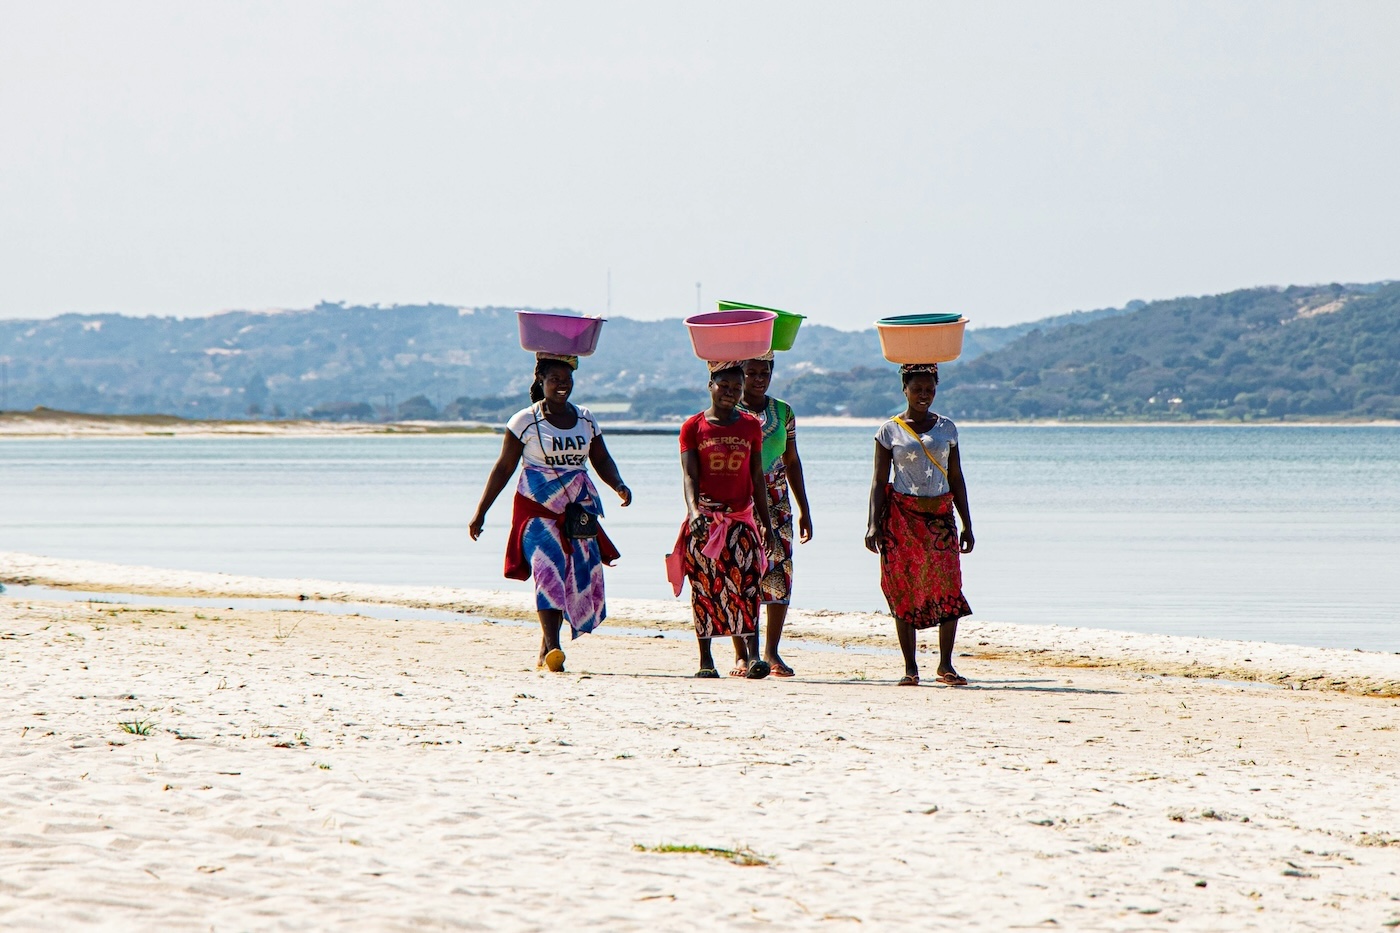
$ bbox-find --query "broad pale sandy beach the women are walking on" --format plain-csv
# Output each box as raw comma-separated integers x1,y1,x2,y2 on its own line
0,555,1400,930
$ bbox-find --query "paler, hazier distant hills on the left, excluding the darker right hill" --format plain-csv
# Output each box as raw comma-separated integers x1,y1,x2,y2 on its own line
0,304,1114,419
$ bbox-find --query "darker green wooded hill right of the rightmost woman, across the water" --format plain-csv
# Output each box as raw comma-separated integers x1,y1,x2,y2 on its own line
948,284,1400,420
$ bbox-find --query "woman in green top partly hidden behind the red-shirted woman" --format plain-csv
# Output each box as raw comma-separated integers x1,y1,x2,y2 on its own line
734,352,812,677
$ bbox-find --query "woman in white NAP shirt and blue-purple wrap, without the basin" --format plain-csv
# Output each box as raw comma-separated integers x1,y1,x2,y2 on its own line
469,353,631,671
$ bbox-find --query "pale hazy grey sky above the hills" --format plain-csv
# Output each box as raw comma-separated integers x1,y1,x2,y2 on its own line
0,0,1400,328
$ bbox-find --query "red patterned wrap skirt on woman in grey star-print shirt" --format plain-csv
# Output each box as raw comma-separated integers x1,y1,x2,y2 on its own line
879,486,972,629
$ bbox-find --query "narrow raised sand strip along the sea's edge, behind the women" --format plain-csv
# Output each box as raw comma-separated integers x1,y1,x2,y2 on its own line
0,552,1400,698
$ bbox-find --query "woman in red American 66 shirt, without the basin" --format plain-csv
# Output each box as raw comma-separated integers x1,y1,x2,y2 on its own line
666,361,781,679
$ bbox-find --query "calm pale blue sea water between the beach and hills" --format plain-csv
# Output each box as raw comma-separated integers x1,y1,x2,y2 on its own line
0,426,1400,651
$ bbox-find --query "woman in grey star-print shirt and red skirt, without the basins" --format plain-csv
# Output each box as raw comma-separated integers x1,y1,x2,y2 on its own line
865,363,976,686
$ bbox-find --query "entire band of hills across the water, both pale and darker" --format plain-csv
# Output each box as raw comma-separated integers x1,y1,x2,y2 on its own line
0,284,1400,420
